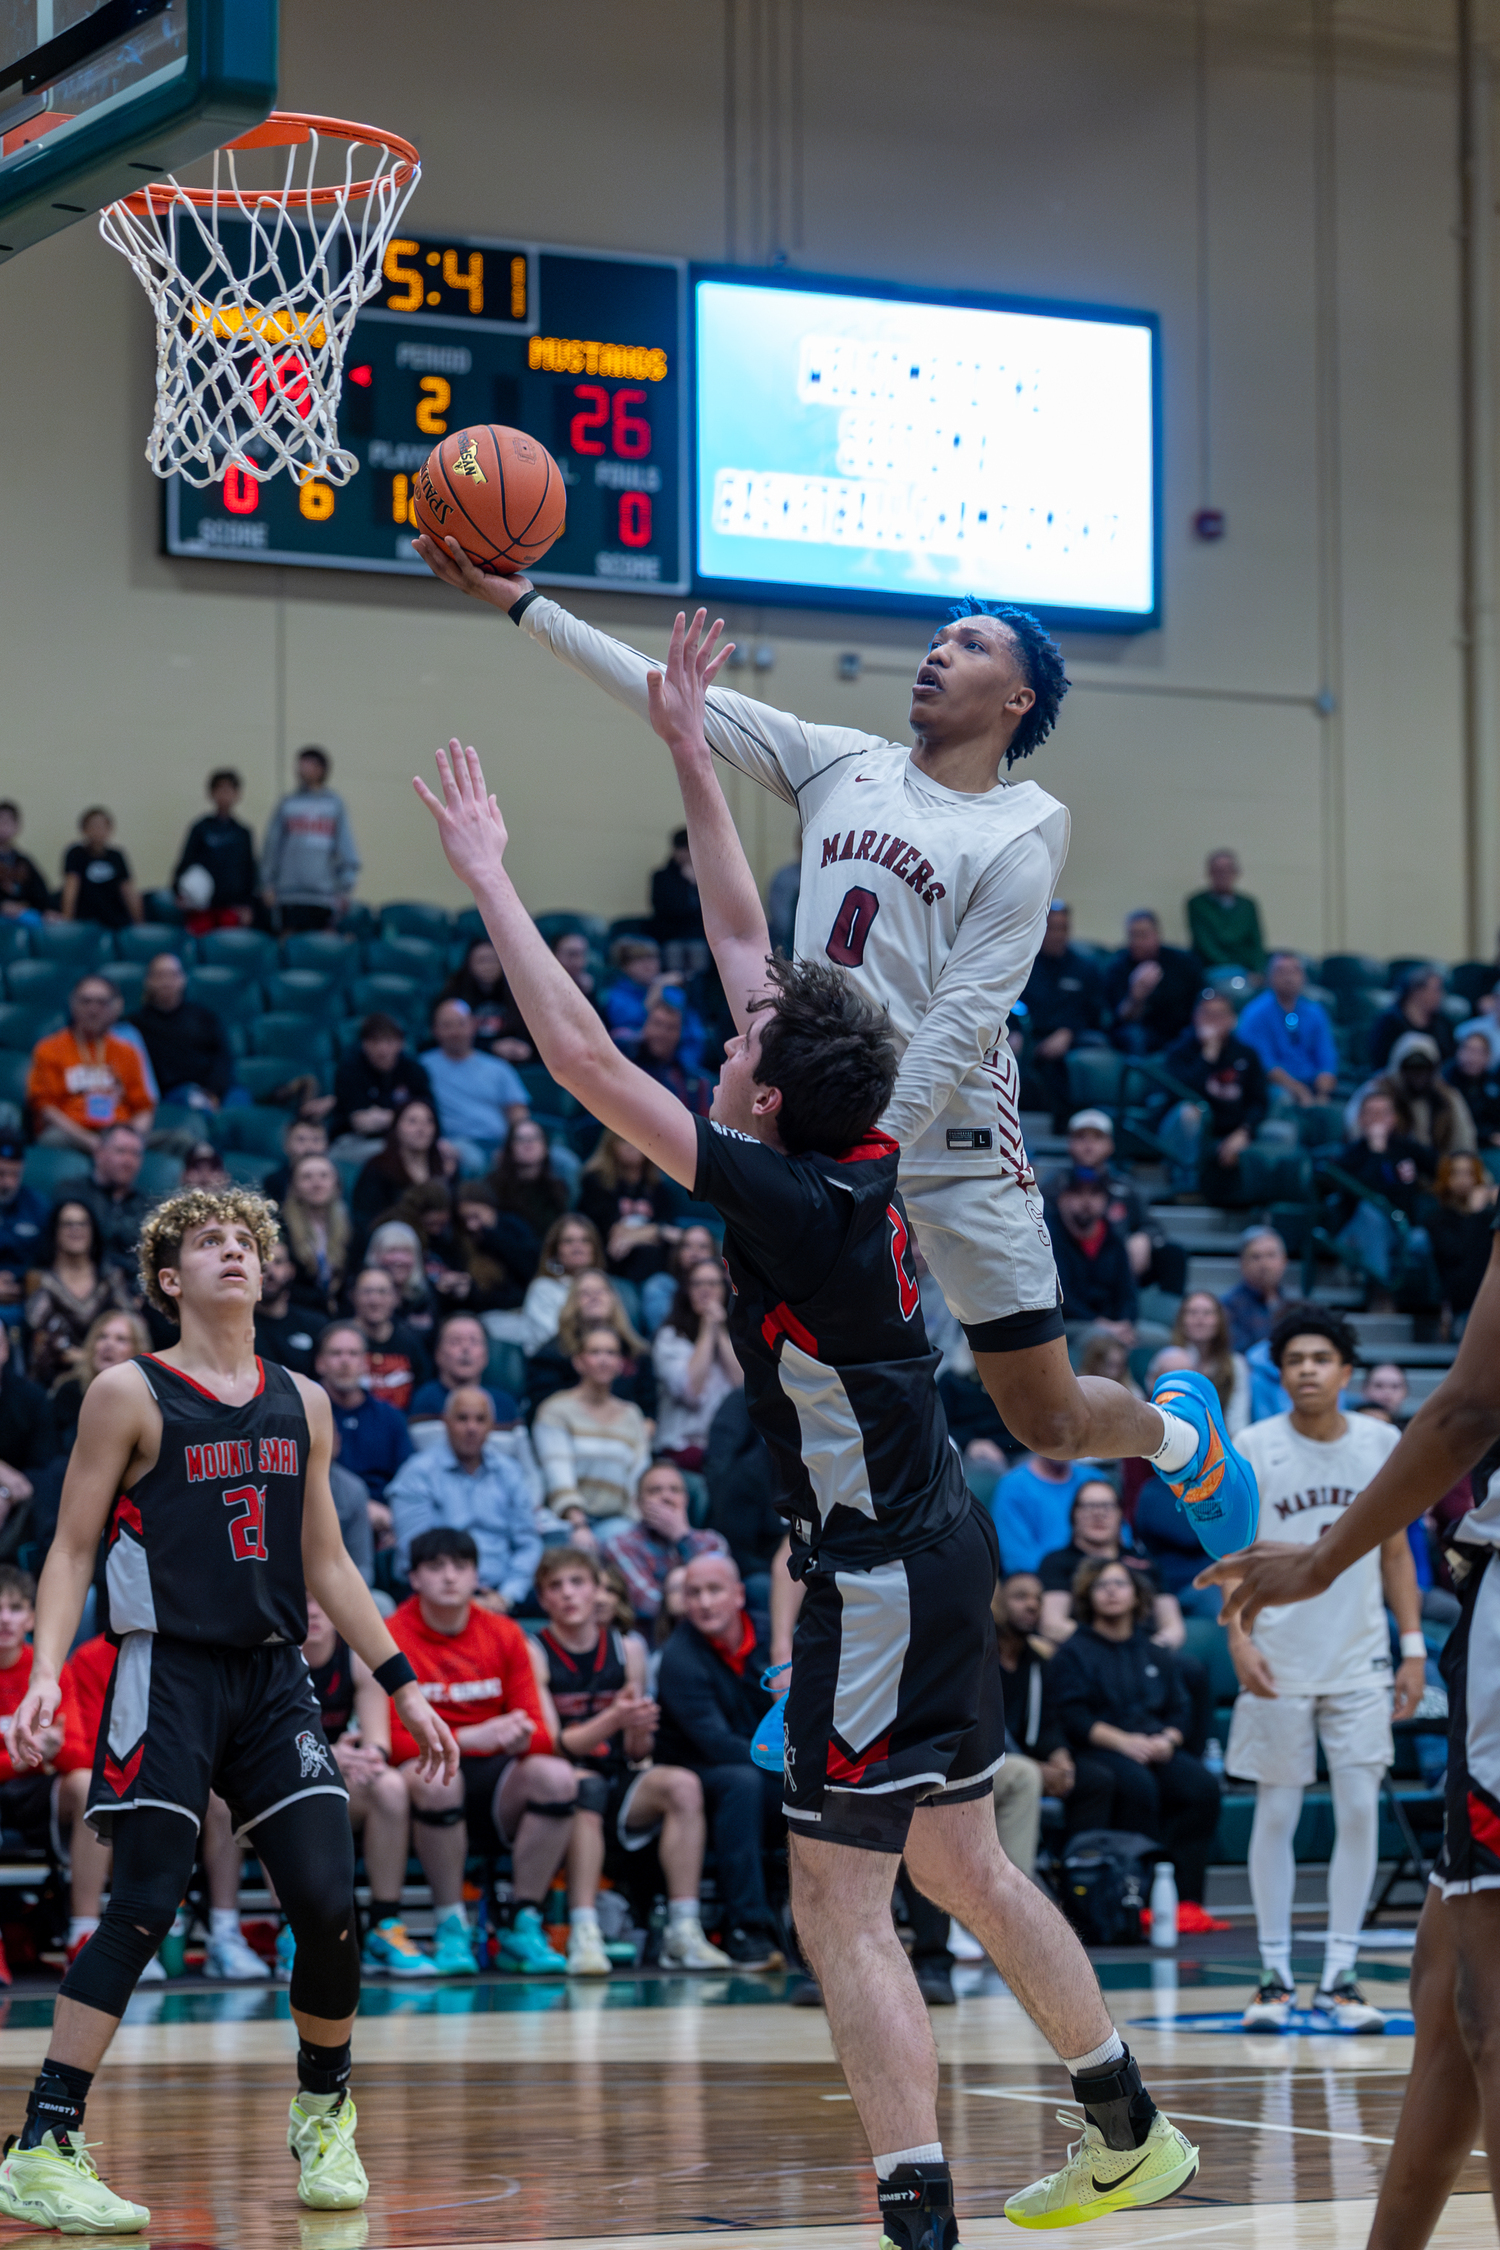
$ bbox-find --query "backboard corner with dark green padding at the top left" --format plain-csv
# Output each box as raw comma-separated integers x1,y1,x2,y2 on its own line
0,0,277,263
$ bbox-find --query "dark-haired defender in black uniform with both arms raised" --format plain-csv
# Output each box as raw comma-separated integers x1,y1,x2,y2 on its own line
416,612,1199,2250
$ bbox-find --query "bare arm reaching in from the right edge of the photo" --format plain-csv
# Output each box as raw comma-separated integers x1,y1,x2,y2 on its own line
1194,1238,1500,1629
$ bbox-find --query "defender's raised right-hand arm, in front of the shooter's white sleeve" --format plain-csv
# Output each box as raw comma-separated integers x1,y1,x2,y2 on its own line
648,610,771,1031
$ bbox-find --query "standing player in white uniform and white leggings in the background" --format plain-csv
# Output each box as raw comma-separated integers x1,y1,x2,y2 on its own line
1223,1305,1426,2032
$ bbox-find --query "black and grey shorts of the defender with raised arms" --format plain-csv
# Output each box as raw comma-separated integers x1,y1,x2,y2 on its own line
783,1508,1005,1854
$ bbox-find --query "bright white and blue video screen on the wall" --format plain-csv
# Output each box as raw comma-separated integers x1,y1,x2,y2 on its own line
695,275,1158,630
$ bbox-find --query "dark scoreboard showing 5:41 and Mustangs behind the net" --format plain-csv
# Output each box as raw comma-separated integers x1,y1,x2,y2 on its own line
164,236,690,594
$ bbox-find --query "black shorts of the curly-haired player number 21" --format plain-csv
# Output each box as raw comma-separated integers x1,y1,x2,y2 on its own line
85,1634,349,1836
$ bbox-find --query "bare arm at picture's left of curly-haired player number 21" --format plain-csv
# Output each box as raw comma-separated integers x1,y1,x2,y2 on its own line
11,1366,148,1771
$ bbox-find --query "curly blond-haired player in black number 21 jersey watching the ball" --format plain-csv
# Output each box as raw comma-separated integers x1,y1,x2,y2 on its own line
0,1188,459,2234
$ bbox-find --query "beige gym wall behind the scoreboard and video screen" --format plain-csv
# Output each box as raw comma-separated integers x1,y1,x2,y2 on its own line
0,0,1493,954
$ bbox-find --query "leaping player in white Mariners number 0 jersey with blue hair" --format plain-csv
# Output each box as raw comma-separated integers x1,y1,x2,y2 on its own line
414,536,1253,1512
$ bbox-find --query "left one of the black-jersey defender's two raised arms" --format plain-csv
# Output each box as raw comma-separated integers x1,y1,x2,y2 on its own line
412,740,697,1188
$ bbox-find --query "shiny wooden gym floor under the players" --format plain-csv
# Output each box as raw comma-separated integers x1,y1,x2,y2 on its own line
0,1958,1496,2250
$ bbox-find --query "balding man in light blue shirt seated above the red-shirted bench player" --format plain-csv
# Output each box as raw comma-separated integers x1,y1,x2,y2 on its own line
385,1384,542,1611
